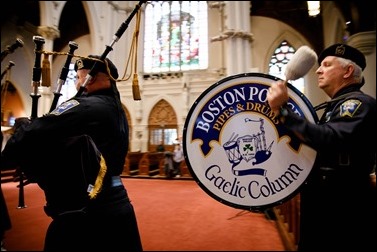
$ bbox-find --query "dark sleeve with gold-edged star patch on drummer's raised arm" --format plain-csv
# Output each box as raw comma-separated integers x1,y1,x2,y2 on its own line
284,94,376,150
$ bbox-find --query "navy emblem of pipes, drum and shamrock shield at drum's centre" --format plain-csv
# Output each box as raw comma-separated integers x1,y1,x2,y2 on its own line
223,118,274,175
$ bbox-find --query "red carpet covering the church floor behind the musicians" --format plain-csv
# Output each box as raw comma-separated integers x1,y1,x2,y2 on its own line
1,178,284,251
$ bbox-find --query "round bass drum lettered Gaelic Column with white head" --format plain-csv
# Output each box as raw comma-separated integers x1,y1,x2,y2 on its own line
183,73,318,212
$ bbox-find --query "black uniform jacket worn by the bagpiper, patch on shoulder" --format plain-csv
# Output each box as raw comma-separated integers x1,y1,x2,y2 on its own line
2,89,128,215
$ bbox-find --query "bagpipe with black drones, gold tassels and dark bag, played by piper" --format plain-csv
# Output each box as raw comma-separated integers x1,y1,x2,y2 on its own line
2,1,146,210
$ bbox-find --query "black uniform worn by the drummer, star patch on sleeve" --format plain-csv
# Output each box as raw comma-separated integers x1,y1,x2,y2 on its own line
284,84,376,250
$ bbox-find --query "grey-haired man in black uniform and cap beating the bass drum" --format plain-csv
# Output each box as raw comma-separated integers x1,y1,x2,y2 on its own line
267,44,377,251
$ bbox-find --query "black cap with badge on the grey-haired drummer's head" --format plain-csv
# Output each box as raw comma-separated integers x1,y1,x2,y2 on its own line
318,44,366,70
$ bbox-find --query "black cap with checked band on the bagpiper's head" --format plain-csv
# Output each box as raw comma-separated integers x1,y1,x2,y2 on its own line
75,55,118,79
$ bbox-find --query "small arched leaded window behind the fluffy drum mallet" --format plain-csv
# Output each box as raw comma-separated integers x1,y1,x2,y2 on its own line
269,40,305,93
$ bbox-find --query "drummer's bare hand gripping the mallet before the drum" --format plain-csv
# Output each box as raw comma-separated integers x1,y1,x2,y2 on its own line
267,81,289,115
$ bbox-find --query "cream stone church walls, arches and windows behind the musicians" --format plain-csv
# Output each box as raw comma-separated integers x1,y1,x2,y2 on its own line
1,1,376,152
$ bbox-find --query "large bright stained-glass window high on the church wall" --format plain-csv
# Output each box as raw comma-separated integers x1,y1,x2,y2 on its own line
144,1,208,73
